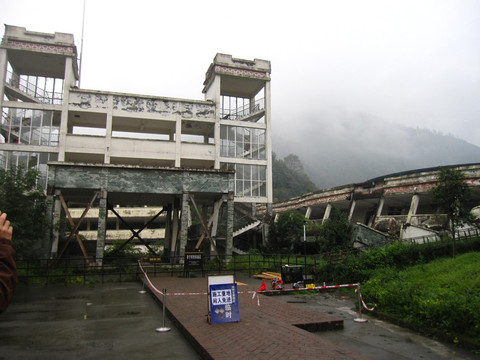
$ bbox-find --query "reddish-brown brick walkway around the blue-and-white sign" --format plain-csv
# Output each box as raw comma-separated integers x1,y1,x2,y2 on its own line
144,277,368,360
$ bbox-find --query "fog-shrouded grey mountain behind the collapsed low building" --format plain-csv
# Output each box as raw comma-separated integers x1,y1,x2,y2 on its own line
273,109,480,189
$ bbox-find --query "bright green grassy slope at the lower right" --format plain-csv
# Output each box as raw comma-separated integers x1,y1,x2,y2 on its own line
362,252,480,339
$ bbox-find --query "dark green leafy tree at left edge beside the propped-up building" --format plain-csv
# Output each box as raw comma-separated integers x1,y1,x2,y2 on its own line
0,166,46,259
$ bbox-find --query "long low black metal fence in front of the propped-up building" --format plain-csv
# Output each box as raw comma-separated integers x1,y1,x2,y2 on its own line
17,254,339,284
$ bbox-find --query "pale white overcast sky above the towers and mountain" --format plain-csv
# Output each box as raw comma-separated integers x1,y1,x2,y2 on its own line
0,0,480,147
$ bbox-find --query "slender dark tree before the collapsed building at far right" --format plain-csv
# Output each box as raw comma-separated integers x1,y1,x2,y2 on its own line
432,168,472,257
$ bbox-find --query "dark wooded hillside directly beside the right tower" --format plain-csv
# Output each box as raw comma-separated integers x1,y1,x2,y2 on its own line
272,154,317,202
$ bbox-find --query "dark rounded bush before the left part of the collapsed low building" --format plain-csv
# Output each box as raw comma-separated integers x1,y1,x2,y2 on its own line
319,207,352,252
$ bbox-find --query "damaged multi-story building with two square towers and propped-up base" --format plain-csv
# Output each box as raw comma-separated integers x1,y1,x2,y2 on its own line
0,25,272,262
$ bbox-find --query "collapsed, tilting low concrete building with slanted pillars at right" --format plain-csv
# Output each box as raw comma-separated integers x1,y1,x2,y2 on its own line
273,164,480,246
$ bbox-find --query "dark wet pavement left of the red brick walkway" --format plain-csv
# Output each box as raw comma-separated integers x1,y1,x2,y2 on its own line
0,283,200,360
